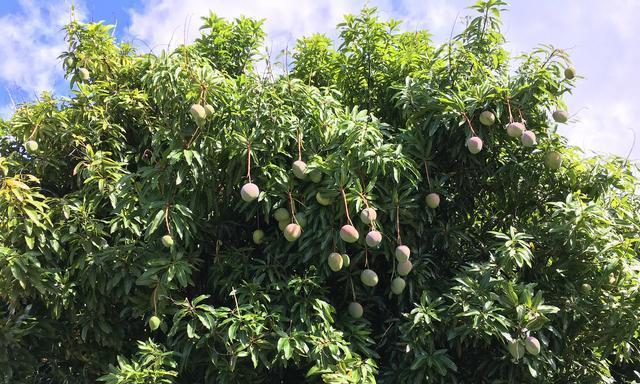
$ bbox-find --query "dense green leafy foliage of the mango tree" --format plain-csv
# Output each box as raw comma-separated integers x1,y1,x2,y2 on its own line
0,0,640,384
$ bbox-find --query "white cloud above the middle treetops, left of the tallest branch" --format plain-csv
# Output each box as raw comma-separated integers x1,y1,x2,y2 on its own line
127,0,466,52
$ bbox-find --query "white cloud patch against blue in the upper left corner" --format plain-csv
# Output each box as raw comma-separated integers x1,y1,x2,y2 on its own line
0,0,81,116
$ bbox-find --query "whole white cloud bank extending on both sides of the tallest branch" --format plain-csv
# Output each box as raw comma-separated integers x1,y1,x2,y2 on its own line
128,0,640,159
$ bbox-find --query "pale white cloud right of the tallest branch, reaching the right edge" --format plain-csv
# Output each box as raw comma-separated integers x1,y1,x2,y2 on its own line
505,0,640,160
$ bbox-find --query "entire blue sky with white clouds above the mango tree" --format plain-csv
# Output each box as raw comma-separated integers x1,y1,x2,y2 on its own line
0,0,640,160
